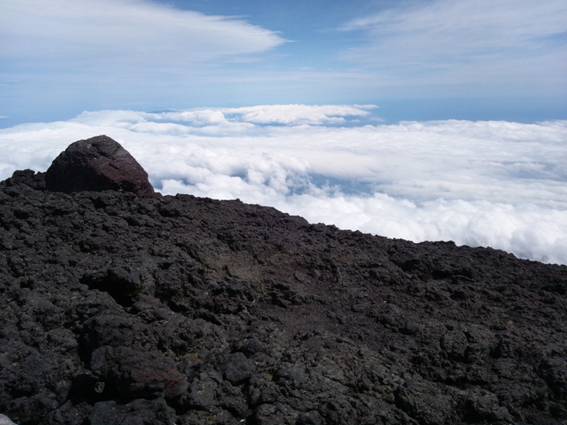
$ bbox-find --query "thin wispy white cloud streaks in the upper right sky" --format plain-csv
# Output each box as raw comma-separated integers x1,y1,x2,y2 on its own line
341,0,567,95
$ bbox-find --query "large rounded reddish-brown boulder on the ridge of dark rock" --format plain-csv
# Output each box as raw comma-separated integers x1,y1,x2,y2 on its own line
45,136,155,196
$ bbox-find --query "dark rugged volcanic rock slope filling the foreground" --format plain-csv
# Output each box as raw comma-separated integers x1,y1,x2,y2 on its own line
0,138,567,425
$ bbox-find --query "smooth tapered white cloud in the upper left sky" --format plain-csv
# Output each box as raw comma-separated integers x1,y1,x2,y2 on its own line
0,0,284,66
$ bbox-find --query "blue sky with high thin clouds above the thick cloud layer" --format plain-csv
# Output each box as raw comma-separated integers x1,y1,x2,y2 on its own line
0,0,567,127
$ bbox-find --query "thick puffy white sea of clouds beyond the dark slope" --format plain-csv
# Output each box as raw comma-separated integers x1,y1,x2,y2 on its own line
0,105,567,264
